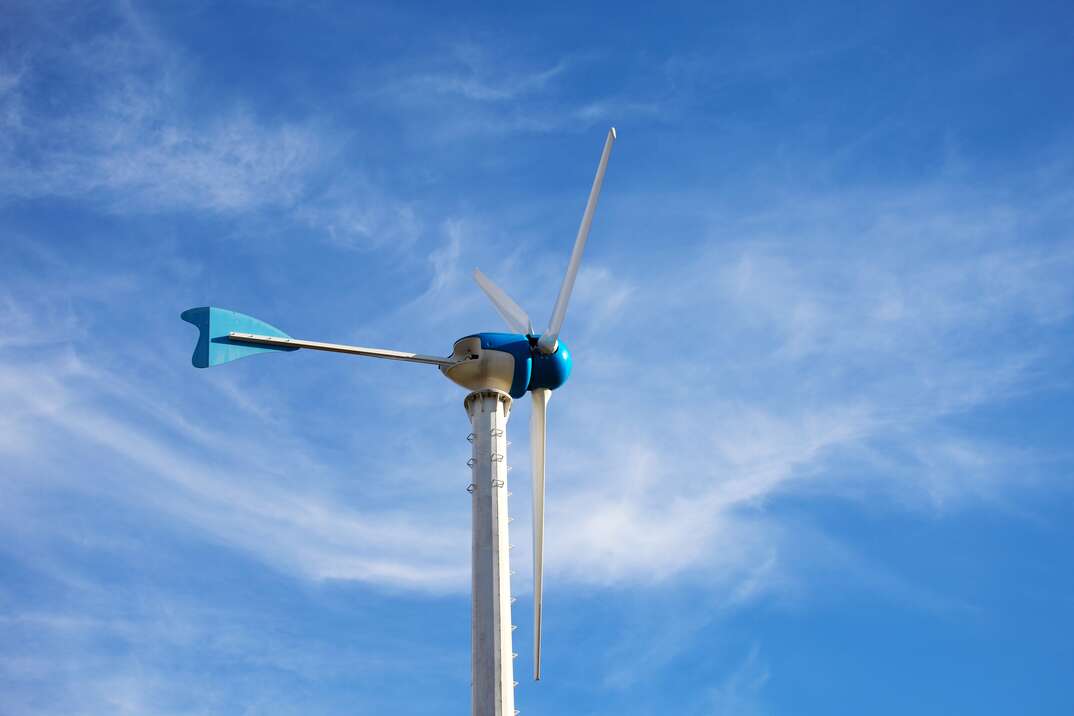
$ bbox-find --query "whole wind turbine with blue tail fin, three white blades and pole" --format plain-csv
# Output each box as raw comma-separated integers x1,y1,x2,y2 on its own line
182,128,615,716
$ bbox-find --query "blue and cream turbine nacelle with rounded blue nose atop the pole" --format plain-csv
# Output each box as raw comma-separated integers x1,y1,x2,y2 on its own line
440,333,571,398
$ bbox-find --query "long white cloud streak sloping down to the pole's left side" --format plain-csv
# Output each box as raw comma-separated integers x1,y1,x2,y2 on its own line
0,357,467,591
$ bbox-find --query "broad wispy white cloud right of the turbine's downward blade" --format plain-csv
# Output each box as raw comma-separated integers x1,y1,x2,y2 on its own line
534,174,1074,598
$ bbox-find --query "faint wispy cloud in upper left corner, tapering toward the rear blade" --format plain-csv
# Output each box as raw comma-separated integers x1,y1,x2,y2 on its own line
0,4,422,248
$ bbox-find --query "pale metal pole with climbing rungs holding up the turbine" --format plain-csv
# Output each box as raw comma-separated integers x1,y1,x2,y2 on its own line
464,390,516,716
